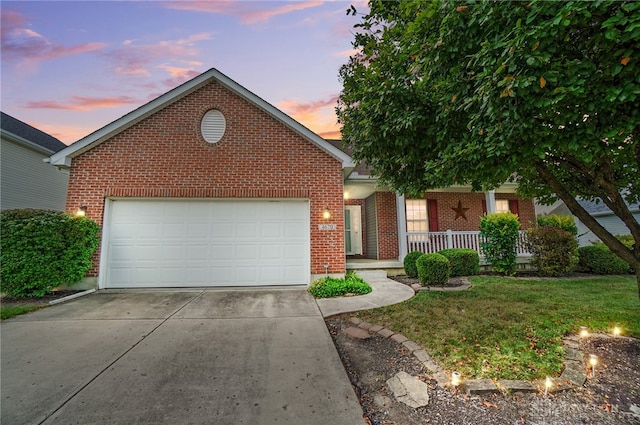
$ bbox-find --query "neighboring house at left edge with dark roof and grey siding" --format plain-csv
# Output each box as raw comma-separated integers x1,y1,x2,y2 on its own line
0,112,69,211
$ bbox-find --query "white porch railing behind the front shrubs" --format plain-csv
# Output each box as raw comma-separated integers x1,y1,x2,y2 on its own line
407,230,531,257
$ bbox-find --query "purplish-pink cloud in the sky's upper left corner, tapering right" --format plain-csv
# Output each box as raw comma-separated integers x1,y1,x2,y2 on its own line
2,10,107,72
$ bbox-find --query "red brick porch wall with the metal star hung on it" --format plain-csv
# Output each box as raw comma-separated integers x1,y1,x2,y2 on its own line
424,192,535,232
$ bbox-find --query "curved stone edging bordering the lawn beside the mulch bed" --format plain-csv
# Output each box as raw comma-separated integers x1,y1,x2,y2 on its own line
349,317,607,395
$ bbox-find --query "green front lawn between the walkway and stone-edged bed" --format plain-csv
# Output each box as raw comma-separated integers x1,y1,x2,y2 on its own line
358,276,640,380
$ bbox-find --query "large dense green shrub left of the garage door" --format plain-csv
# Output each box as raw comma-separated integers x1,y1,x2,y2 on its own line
0,209,100,298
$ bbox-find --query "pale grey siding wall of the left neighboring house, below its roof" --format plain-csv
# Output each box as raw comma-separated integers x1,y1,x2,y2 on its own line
0,139,69,211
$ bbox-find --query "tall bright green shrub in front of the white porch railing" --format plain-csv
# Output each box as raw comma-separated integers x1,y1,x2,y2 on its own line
480,212,520,275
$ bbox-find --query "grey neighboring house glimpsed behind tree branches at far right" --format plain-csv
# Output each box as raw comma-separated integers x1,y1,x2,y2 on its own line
549,199,640,246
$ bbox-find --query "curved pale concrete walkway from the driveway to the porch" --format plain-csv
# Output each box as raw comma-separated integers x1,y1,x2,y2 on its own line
316,270,415,317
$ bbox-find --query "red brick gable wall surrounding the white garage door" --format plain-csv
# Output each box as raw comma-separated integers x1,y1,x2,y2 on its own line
67,82,345,276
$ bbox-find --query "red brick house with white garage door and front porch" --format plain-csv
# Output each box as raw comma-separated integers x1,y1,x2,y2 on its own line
50,69,533,288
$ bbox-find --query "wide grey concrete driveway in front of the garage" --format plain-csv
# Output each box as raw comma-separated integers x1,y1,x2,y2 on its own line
0,289,364,425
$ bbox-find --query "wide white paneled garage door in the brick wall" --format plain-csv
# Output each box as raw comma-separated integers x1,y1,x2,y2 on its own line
102,200,310,288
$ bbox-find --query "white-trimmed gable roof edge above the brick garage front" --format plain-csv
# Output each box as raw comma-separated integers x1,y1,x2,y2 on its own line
49,68,353,171
